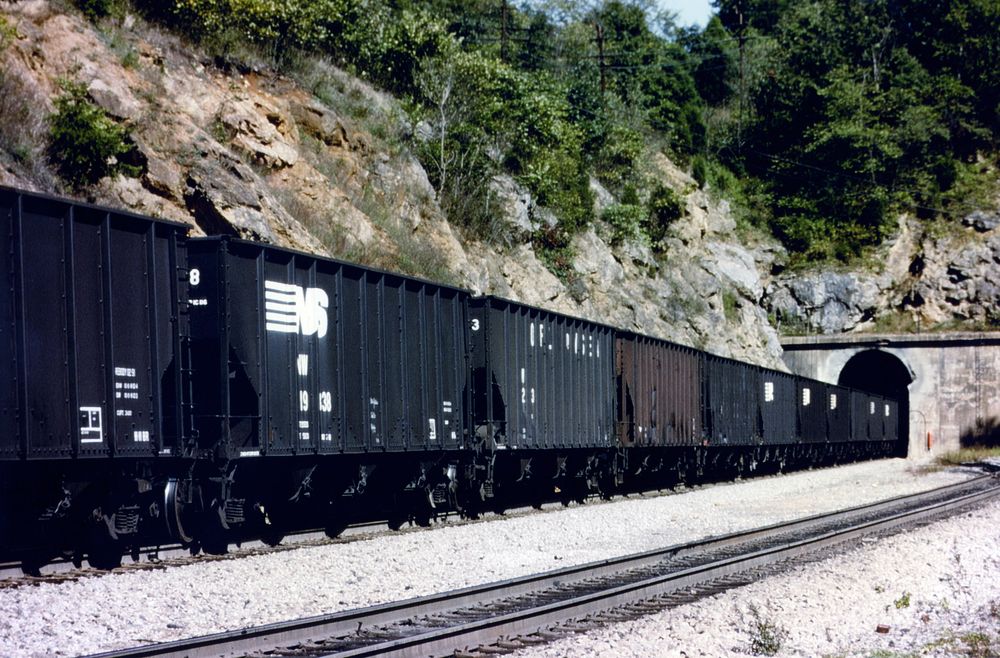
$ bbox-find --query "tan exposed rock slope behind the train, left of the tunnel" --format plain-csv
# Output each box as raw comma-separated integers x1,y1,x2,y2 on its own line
0,0,782,367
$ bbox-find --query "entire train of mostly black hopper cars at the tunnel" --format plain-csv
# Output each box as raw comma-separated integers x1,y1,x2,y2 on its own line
0,188,902,572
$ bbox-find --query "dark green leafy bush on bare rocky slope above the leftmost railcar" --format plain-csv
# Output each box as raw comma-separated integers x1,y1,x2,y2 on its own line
48,80,136,187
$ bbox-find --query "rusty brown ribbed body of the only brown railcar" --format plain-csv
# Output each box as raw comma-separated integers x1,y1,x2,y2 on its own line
615,332,702,447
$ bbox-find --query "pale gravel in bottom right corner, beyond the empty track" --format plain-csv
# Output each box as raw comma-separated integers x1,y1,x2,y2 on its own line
514,494,1000,658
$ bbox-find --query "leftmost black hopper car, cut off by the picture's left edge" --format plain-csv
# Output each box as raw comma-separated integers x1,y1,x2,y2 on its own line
0,189,187,555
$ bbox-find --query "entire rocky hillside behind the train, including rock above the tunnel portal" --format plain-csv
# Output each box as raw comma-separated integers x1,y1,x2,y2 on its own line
0,0,1000,367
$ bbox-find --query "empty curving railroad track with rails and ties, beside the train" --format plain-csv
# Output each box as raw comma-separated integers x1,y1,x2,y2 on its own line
82,476,1000,658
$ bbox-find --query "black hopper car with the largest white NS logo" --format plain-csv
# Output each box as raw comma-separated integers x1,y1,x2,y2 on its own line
188,238,467,540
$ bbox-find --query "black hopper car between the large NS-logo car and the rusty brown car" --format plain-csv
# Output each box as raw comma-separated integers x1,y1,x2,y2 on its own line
469,297,616,502
